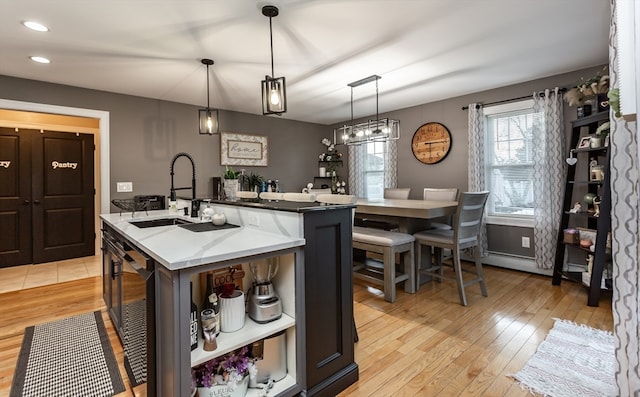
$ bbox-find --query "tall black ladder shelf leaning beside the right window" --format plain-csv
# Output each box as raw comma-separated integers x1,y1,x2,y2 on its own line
552,110,611,306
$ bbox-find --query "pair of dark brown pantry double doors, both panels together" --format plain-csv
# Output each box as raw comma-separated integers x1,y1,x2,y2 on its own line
0,127,95,267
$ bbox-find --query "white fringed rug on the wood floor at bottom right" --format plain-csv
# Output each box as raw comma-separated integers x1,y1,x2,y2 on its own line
511,319,616,397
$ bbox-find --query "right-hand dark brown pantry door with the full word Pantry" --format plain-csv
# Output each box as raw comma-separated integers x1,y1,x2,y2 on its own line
31,132,96,263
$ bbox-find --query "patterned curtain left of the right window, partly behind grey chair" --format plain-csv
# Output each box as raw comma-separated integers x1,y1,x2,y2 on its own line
468,103,488,256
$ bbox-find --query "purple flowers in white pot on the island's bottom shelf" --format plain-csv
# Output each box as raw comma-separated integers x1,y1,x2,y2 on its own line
191,346,257,397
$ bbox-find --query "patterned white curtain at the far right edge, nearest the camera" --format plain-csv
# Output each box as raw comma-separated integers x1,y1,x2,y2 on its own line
609,0,640,396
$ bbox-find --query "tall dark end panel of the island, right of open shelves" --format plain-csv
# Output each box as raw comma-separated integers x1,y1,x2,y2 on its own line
304,208,358,396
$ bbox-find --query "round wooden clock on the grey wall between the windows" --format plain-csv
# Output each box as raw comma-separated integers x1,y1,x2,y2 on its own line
411,122,451,164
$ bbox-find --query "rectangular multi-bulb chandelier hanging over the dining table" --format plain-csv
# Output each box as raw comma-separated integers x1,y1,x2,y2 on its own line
334,74,400,146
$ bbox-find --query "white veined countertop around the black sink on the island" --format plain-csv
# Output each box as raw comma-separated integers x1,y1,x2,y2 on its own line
100,210,305,270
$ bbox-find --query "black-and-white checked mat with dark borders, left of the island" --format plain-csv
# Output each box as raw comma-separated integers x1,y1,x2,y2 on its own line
9,312,125,397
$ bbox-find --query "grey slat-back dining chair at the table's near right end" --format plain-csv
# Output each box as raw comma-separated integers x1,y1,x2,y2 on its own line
413,191,489,306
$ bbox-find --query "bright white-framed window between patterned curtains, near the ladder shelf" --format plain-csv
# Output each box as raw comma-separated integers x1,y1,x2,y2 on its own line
484,100,543,219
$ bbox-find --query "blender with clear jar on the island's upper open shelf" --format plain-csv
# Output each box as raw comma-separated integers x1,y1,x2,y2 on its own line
248,257,282,324
